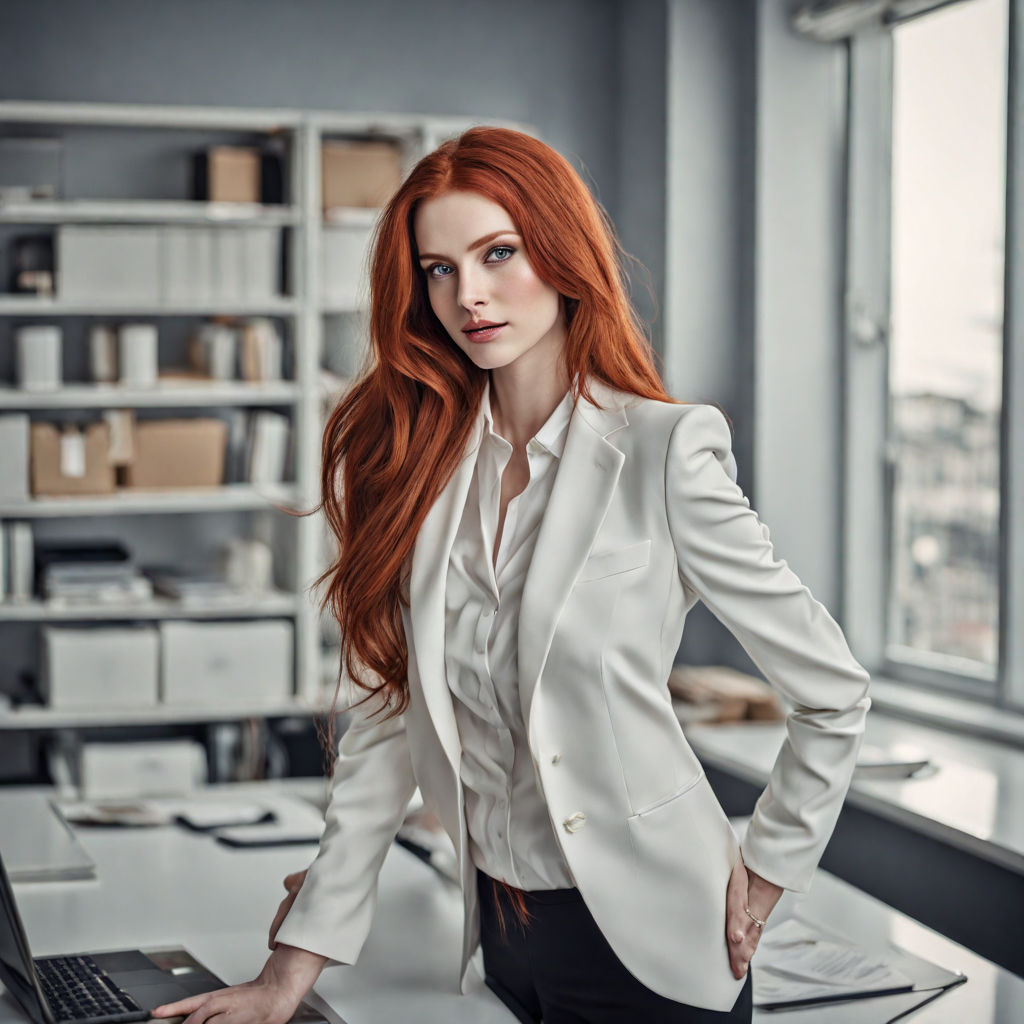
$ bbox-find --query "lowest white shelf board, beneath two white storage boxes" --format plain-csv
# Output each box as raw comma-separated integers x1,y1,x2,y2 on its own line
0,697,323,732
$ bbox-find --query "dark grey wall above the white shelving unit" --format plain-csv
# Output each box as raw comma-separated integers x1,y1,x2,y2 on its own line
0,0,618,222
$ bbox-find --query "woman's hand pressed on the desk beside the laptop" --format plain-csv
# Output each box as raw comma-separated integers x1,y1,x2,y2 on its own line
151,943,328,1024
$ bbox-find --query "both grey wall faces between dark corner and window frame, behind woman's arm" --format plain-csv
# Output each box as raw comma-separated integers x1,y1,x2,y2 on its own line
665,0,846,669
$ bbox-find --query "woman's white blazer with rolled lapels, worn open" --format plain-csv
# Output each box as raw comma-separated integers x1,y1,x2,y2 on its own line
278,383,869,1011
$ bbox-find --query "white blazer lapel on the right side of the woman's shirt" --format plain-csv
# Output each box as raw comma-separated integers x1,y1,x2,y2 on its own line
518,382,629,735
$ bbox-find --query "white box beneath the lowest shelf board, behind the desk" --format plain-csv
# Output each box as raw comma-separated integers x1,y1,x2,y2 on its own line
79,739,207,800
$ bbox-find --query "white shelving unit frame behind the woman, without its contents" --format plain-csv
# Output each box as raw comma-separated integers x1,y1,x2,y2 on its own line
0,102,528,741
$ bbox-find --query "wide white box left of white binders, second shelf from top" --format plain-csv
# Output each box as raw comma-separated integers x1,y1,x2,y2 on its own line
56,224,161,305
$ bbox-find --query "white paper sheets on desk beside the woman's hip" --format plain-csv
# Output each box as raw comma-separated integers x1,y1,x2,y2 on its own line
754,918,913,1008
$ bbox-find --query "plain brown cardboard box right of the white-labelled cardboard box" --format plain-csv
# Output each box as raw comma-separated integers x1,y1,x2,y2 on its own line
125,418,227,488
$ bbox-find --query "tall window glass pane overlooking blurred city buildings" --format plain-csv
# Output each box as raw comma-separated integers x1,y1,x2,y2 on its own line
888,0,1009,679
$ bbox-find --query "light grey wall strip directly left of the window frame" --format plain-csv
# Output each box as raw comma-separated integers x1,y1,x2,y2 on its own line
752,0,847,611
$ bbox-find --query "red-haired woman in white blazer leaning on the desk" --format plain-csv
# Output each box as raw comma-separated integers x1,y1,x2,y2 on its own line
153,128,868,1024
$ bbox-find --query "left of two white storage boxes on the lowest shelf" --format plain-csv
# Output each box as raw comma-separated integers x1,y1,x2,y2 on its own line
39,626,160,708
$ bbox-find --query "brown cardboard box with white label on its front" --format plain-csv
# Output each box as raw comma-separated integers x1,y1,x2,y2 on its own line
30,423,117,497
